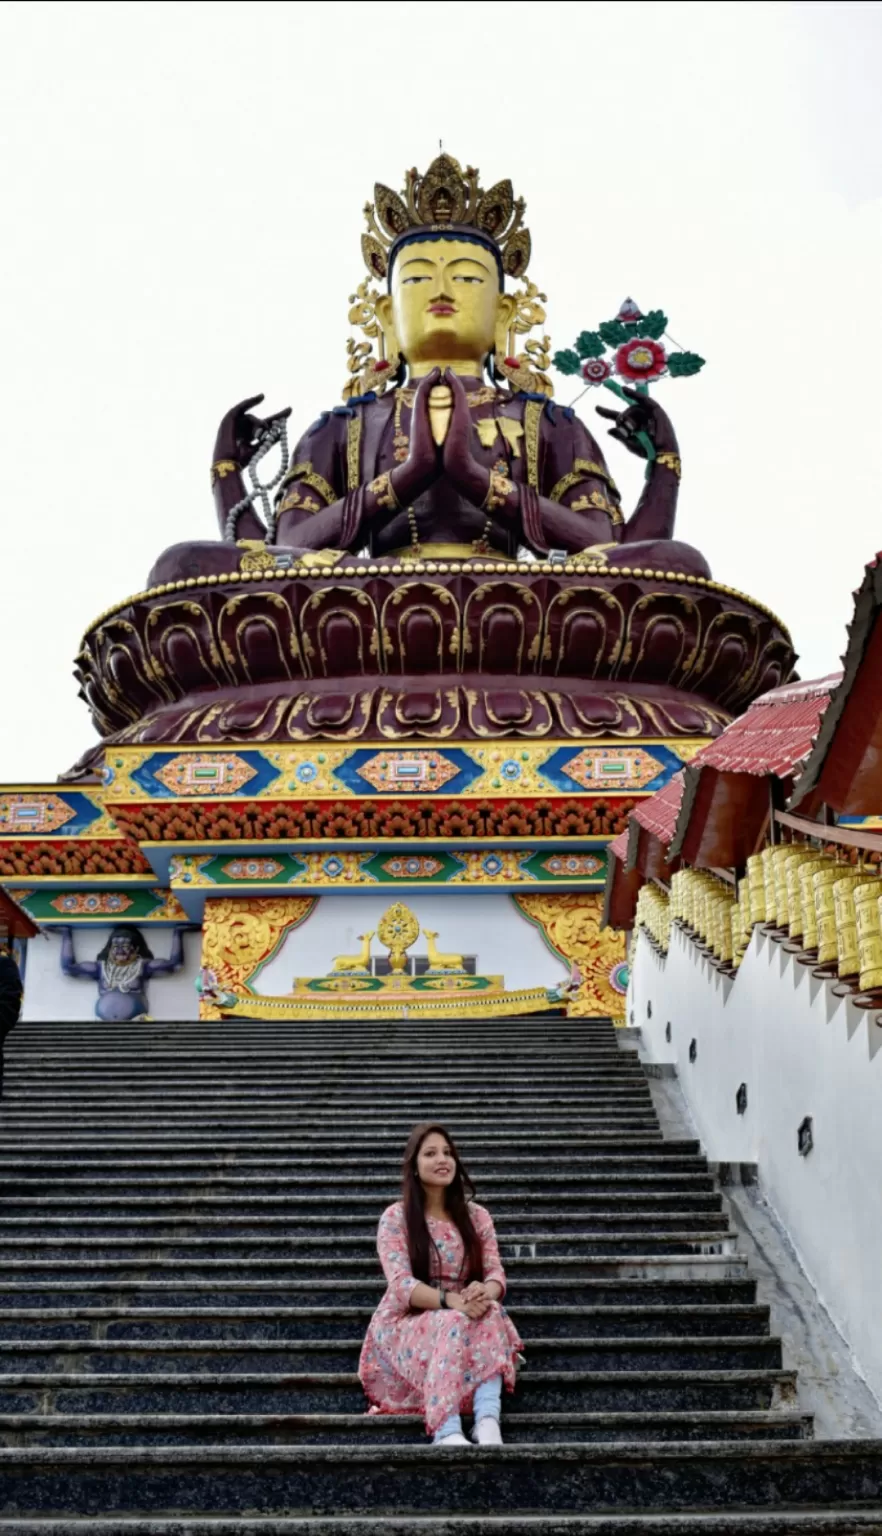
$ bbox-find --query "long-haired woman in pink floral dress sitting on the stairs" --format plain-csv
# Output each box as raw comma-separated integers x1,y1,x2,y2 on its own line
358,1124,521,1445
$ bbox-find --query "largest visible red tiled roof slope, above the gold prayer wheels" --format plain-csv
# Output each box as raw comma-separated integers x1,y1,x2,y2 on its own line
688,673,842,780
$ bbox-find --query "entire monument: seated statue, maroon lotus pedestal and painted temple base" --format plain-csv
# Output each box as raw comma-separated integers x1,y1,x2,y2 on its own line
0,155,794,1023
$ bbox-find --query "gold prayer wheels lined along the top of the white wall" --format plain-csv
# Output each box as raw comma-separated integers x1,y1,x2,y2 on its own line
663,843,882,1008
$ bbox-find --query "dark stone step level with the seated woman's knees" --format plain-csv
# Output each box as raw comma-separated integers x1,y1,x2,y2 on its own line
0,1333,781,1376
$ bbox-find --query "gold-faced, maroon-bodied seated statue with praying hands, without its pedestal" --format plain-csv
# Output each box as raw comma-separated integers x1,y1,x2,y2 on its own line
149,155,710,587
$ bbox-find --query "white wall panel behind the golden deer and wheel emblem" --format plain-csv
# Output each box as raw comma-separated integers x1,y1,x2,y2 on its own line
255,891,569,997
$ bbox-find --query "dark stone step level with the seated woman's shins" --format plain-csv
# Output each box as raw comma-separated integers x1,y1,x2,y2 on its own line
0,1362,796,1418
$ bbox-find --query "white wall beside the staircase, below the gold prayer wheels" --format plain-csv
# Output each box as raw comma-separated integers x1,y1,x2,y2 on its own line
628,928,882,1399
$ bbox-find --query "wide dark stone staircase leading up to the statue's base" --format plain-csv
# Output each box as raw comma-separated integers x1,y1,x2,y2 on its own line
0,1020,882,1536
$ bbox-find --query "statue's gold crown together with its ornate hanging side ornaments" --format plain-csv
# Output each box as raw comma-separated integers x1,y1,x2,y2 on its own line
343,154,552,399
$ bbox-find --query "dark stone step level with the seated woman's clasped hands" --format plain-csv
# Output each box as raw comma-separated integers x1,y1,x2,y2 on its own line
0,1273,756,1315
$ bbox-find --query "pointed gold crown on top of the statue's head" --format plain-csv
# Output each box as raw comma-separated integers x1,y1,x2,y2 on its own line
361,154,532,288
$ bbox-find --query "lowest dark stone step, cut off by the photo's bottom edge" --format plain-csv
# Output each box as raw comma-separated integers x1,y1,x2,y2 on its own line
0,1502,879,1536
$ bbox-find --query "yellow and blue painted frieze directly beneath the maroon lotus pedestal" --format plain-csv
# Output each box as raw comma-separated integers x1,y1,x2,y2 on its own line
104,737,704,808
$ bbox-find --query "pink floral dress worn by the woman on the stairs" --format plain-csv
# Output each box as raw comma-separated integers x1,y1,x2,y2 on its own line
358,1201,522,1435
